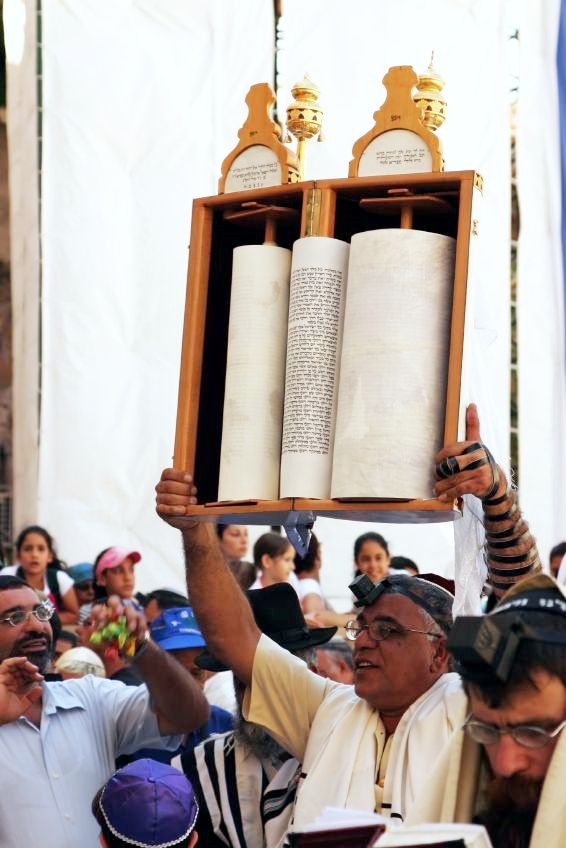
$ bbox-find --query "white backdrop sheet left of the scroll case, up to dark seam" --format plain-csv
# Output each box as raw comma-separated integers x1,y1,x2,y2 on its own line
38,0,273,588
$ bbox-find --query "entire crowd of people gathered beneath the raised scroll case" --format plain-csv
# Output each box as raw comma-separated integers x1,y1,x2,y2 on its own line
0,407,566,848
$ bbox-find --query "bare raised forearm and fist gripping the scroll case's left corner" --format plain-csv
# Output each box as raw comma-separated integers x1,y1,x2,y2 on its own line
155,468,261,684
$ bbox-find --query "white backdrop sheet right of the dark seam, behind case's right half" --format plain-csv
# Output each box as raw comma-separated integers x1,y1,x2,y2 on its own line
268,0,510,604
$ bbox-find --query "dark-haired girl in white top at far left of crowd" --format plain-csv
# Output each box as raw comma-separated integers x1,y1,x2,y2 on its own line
2,525,79,624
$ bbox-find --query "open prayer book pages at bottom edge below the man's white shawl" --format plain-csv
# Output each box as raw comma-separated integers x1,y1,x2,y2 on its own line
288,807,492,848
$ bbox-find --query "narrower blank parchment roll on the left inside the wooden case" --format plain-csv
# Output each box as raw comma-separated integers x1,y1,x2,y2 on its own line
218,244,291,501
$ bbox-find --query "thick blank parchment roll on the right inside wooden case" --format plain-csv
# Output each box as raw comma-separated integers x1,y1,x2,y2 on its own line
331,229,456,499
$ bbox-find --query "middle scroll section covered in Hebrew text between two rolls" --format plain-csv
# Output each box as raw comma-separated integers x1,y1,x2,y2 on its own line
280,236,349,498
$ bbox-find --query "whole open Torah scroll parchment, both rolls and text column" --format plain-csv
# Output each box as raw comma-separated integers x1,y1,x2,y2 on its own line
218,228,456,501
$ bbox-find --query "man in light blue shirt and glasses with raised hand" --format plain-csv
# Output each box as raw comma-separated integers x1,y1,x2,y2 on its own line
0,575,209,848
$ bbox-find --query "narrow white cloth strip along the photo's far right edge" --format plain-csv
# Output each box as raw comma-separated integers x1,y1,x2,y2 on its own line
517,0,566,560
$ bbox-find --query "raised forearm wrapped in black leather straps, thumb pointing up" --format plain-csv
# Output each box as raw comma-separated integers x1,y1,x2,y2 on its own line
435,404,541,597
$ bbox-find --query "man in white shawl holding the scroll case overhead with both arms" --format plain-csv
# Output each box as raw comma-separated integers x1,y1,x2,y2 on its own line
156,407,540,840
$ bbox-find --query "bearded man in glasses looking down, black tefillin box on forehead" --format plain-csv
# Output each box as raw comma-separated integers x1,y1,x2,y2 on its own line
409,575,566,848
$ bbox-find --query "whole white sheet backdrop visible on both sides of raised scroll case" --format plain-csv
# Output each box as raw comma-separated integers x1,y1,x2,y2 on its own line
6,0,540,602
